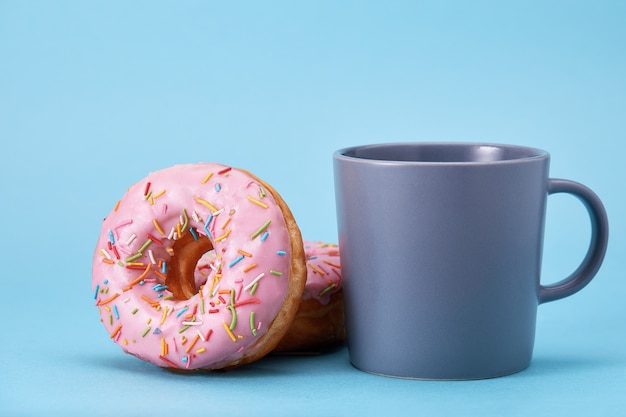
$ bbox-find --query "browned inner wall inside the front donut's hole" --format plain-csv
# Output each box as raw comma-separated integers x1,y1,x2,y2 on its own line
165,233,214,300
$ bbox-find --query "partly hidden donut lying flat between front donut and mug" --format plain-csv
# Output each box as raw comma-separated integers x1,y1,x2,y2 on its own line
274,240,345,353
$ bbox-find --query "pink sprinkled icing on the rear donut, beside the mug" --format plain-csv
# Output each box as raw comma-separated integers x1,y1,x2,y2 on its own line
302,240,341,305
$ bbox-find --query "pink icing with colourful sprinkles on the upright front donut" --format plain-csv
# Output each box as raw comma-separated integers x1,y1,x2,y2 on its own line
92,163,291,369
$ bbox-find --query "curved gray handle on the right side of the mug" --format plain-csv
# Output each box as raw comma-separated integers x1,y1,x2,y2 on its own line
539,178,609,304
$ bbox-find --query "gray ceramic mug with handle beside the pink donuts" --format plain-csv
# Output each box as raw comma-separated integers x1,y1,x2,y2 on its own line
333,143,608,379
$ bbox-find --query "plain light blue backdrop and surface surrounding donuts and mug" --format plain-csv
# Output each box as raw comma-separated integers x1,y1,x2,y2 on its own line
0,0,626,416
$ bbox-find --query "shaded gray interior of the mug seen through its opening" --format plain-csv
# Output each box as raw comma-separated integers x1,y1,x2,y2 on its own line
339,143,547,163
